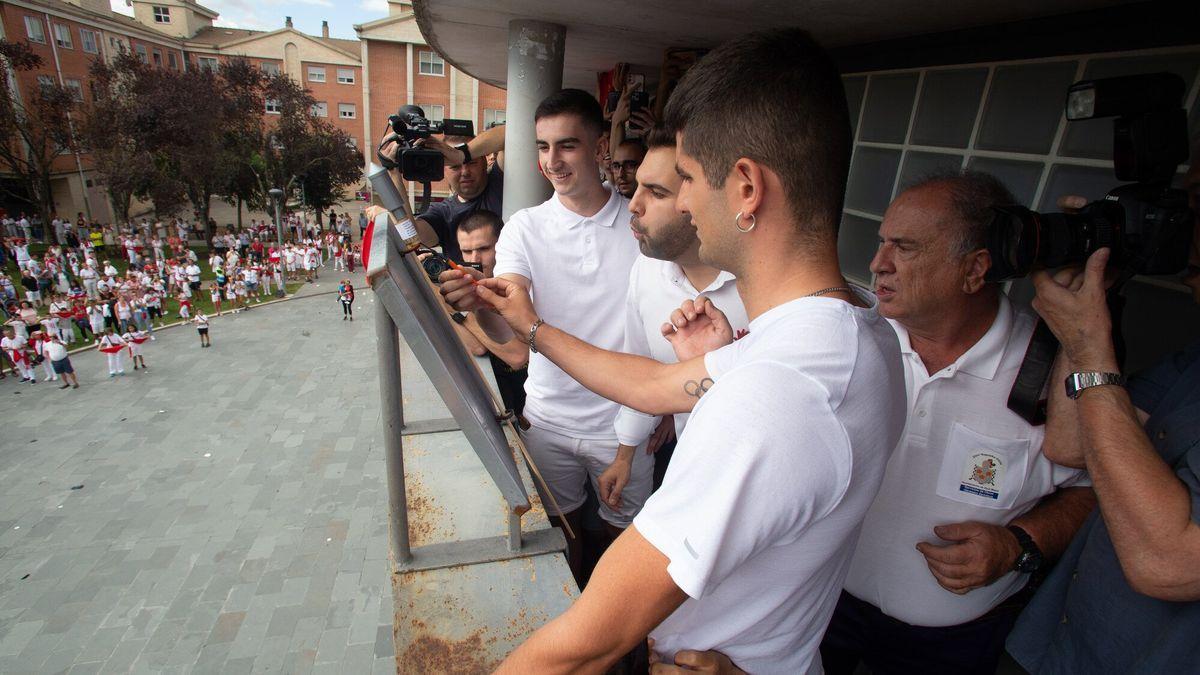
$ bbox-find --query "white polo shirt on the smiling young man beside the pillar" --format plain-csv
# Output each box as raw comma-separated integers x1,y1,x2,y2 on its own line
494,186,638,440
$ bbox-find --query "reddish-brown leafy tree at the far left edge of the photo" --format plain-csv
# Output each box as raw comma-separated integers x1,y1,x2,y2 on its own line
0,40,77,222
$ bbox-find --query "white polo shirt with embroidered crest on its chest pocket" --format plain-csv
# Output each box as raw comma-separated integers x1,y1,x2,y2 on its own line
846,294,1091,626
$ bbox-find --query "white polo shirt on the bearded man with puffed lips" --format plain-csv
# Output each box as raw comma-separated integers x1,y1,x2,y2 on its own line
613,256,750,447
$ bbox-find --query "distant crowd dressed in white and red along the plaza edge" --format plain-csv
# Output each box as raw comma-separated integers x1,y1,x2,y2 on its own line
0,219,361,389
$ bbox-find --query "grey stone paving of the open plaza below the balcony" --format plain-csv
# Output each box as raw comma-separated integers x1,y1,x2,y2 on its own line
0,273,395,673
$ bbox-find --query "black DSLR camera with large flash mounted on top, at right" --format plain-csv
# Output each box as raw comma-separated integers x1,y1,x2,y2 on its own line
988,72,1193,281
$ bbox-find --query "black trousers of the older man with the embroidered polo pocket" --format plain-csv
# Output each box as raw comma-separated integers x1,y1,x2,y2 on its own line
821,586,1032,675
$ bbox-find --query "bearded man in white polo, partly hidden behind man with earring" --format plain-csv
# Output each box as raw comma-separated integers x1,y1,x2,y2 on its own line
598,127,750,507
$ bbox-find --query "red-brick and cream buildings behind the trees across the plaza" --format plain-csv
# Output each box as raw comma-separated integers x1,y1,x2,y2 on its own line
0,0,505,222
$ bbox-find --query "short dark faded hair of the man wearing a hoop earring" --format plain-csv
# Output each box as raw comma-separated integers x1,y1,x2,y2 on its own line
664,28,851,239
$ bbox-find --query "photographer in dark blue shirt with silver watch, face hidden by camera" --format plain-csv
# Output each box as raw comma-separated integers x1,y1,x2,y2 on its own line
1008,153,1200,675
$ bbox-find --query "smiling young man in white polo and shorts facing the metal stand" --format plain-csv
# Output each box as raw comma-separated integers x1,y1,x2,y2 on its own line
441,89,653,579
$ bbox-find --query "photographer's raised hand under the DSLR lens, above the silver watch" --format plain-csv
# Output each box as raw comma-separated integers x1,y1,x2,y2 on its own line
1031,249,1118,372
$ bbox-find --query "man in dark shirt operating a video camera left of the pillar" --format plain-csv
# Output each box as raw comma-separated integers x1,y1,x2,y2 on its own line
367,121,504,263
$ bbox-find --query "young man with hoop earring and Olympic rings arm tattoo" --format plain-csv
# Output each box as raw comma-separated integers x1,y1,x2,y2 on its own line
443,29,905,673
